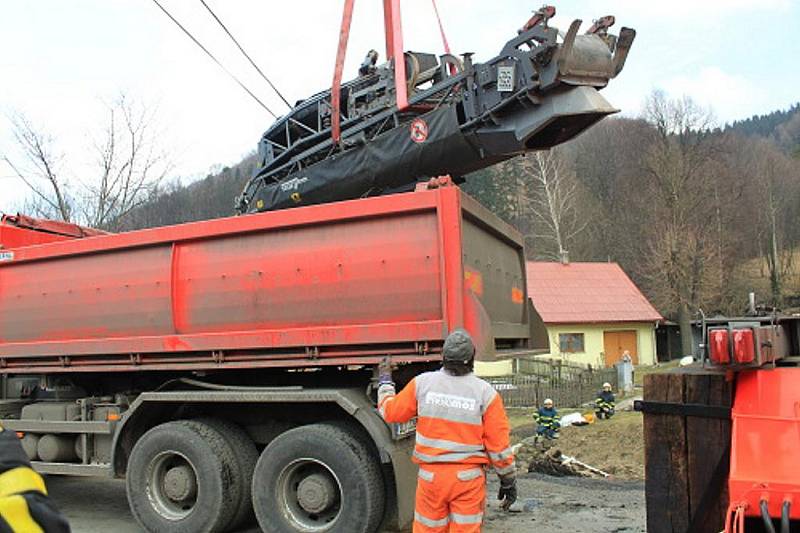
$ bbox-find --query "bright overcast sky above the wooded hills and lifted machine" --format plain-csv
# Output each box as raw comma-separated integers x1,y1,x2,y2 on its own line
0,0,800,212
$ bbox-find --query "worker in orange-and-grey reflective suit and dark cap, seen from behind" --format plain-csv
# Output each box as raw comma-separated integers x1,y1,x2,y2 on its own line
378,330,517,533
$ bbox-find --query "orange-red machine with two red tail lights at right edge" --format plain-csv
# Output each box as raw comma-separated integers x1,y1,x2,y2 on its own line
703,316,800,533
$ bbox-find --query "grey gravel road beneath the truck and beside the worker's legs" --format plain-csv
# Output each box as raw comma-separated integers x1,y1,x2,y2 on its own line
47,474,645,533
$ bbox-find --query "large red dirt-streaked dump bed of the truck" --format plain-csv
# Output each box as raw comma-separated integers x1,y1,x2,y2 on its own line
0,187,532,373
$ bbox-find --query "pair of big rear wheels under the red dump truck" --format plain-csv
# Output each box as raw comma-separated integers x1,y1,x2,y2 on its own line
127,419,385,533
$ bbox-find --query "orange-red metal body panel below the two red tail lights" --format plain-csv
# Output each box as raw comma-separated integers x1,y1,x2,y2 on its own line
729,367,800,520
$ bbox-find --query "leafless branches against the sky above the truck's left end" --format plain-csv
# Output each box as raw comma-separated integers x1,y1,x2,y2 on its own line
5,94,172,230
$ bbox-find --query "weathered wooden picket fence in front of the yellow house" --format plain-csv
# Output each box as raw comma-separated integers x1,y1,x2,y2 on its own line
488,359,617,408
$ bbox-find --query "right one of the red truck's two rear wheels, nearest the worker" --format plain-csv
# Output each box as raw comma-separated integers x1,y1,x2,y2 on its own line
253,424,385,533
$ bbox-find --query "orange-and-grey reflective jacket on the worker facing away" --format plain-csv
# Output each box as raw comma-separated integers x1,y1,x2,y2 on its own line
378,369,515,476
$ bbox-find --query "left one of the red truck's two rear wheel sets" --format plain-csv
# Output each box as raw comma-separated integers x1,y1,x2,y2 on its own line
126,420,242,533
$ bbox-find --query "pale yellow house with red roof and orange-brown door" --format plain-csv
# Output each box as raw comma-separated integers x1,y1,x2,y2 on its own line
476,261,663,376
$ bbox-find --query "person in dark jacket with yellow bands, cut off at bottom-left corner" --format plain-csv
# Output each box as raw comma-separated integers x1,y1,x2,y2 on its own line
0,426,70,533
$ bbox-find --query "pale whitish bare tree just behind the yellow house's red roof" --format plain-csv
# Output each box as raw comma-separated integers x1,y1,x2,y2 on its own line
518,149,587,260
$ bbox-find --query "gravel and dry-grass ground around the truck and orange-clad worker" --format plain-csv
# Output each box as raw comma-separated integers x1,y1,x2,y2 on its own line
47,404,645,533
